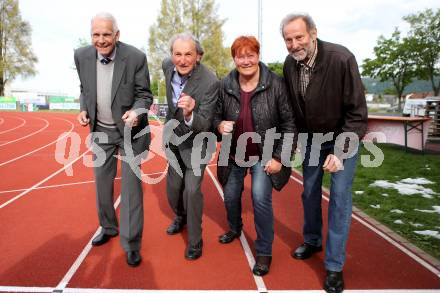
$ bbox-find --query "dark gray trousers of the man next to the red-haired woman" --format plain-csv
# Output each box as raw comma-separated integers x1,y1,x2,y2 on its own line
167,147,206,245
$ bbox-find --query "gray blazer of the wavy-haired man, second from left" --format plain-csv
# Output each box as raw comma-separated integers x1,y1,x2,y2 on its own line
162,58,219,169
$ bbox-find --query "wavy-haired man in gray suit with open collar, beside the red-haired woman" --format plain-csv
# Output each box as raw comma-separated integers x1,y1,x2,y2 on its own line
162,33,218,260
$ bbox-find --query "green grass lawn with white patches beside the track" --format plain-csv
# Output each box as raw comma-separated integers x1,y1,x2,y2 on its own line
300,144,440,260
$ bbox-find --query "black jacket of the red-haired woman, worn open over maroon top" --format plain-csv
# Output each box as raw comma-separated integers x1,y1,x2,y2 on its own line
213,62,297,190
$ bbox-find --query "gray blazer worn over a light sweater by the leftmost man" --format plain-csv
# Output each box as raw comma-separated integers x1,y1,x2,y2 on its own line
74,42,153,153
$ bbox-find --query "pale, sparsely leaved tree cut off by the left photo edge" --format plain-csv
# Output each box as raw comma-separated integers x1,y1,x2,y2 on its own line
0,0,37,96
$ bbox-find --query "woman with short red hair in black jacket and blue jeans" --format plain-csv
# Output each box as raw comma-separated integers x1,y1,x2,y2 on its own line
213,36,296,276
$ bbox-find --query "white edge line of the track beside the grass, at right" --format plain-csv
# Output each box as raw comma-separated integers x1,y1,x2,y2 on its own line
290,175,440,278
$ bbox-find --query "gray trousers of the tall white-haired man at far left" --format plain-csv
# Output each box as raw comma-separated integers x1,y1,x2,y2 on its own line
94,126,144,251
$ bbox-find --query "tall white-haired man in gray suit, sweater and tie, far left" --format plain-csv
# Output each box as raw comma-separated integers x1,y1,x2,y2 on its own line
74,13,153,266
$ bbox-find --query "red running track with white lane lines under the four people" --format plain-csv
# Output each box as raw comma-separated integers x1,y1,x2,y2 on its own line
0,112,440,292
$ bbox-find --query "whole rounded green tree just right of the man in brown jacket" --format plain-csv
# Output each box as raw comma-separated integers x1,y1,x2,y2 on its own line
362,28,416,111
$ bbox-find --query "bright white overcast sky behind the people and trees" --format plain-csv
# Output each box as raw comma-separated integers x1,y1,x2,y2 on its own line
8,0,440,96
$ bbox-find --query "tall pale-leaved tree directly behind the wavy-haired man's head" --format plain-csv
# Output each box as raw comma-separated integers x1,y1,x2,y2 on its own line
148,0,232,79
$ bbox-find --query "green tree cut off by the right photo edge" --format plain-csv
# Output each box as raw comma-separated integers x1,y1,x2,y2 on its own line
403,9,440,96
